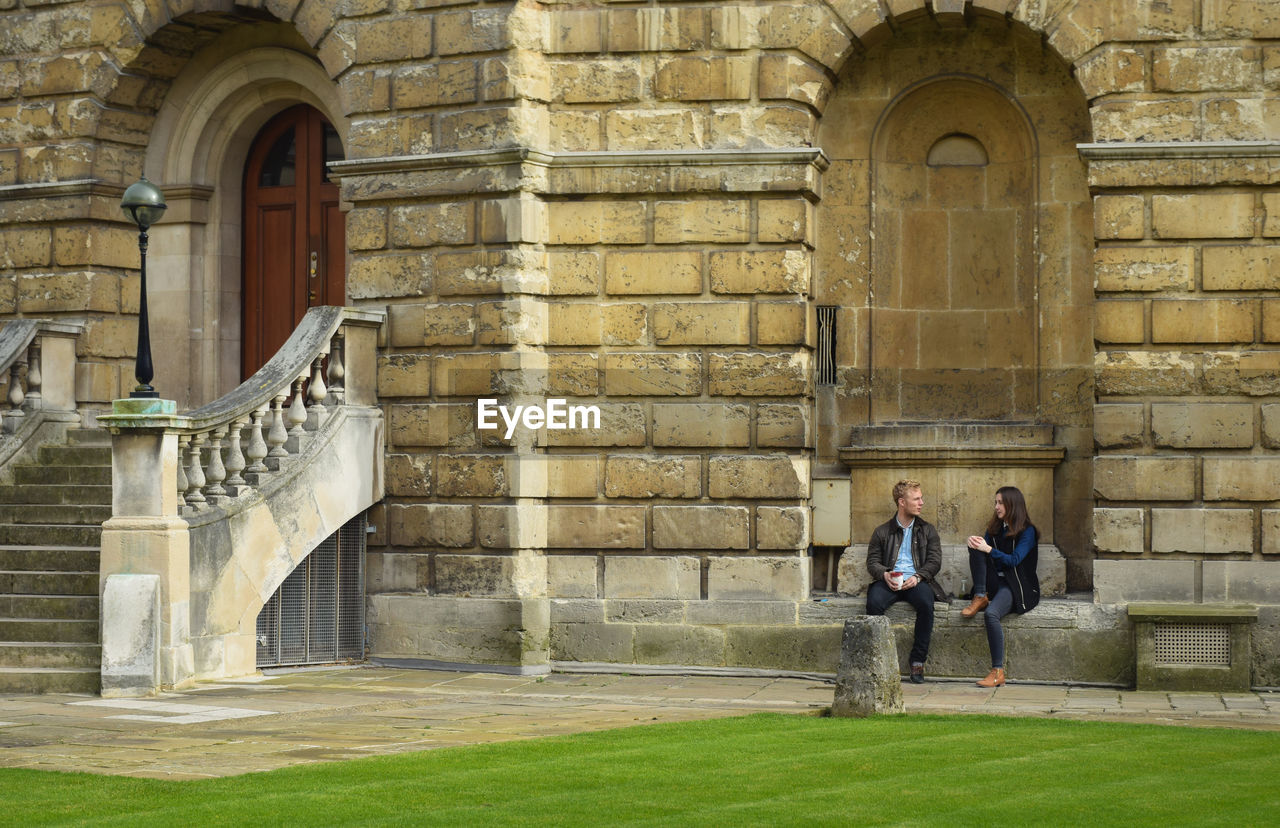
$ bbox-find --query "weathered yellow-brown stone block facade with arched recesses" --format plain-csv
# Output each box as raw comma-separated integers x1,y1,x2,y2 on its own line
0,0,1280,685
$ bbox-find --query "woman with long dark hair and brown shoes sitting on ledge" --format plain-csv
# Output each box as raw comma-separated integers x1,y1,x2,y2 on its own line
960,486,1039,687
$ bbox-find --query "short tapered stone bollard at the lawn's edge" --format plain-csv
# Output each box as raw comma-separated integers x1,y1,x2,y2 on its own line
831,616,904,718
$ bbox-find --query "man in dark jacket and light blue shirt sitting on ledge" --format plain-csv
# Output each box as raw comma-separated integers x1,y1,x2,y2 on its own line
867,480,946,685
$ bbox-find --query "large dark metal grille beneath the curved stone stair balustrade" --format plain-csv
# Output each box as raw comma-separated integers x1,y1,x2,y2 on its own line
257,514,365,667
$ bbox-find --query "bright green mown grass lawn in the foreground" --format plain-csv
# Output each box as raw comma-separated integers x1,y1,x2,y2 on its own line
0,715,1280,827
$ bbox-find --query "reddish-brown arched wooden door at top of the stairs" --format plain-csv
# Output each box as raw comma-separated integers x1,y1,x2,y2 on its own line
241,104,347,378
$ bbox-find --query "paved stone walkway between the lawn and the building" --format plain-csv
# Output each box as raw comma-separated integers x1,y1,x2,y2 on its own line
0,667,1280,779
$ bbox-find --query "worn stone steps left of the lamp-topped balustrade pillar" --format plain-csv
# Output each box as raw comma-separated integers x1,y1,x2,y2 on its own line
0,430,111,694
